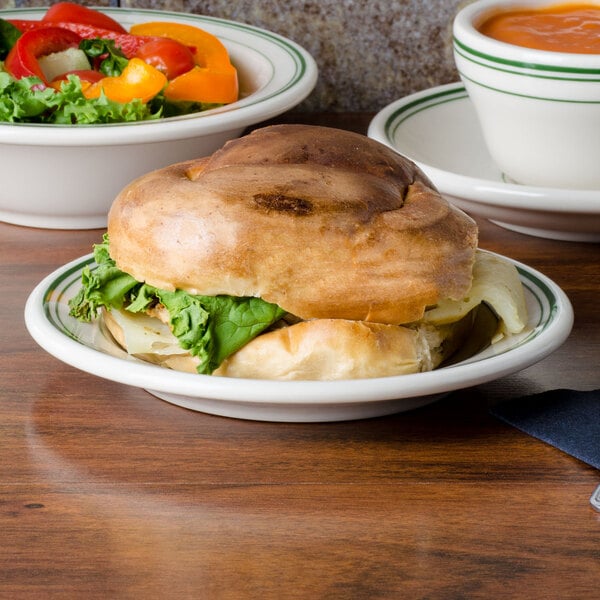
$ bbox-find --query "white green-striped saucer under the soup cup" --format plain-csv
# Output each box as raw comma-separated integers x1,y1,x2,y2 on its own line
368,83,600,242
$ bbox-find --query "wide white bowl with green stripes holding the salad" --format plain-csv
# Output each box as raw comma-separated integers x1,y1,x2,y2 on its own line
0,8,317,229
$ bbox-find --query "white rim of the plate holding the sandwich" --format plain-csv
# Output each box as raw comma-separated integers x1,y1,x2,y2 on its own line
24,250,574,412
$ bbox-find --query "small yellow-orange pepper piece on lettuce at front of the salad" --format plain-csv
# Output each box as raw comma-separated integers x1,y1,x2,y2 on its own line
83,58,167,103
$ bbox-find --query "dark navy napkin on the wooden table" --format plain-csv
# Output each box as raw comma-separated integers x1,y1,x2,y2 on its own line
490,390,600,469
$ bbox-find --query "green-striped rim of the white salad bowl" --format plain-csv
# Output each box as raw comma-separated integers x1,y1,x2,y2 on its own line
0,7,318,146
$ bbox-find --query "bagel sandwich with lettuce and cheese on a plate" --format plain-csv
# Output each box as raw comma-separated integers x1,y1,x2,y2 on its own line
70,125,527,380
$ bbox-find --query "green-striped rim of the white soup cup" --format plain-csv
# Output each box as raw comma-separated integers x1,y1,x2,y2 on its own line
452,0,600,75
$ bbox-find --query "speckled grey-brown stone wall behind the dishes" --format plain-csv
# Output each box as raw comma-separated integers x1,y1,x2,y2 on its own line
0,0,468,112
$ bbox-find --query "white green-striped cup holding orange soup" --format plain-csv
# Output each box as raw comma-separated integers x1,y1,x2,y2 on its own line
453,0,600,189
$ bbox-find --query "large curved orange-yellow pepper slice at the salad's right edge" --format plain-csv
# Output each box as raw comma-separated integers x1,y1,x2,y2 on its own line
130,21,239,104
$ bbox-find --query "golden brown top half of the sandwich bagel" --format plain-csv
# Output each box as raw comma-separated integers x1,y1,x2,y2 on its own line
108,125,477,324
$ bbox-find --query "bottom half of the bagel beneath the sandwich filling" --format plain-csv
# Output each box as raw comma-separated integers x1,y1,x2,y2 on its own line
103,305,497,381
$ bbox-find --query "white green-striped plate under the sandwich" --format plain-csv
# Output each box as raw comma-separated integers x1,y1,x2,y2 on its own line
25,254,573,422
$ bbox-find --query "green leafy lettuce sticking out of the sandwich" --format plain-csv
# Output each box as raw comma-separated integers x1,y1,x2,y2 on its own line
69,234,285,374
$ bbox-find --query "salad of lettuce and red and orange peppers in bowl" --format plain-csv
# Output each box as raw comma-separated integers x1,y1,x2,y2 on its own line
0,2,238,125
